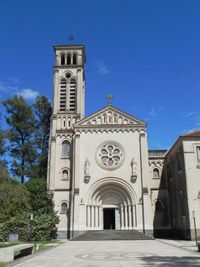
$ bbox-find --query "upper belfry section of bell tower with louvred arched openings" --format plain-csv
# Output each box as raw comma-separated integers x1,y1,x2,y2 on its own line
53,45,86,121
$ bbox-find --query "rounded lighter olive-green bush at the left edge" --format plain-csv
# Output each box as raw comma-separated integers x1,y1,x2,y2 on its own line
0,181,31,222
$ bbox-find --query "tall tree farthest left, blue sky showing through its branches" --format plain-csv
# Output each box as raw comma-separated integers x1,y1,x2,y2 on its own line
3,95,36,183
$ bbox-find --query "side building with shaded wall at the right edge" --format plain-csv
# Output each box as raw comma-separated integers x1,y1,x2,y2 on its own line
165,131,200,239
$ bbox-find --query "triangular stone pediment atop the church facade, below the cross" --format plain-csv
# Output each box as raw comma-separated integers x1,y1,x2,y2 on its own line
74,105,146,127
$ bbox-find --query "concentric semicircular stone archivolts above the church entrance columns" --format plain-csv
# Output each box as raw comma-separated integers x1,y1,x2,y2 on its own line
85,177,137,205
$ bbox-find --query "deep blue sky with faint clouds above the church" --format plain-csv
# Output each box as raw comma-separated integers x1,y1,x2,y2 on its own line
0,0,200,149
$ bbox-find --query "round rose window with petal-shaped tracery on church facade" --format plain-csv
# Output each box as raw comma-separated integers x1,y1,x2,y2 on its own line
97,142,124,169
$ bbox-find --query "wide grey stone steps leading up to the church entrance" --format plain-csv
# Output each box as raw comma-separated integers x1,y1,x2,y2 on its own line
71,230,153,241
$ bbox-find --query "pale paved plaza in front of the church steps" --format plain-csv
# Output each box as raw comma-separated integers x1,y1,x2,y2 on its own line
10,240,200,267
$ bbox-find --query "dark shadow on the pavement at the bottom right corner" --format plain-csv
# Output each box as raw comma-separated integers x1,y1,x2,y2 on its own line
141,256,200,267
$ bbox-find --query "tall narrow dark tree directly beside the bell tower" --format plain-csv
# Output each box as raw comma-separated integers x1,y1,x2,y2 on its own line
31,96,52,179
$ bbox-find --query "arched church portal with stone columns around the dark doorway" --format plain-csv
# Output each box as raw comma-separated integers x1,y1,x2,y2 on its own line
86,178,137,230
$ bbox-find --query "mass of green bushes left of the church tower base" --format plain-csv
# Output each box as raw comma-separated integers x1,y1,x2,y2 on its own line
0,178,59,241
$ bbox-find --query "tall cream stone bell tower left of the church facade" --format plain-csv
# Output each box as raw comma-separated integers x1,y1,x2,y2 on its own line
47,45,86,195
